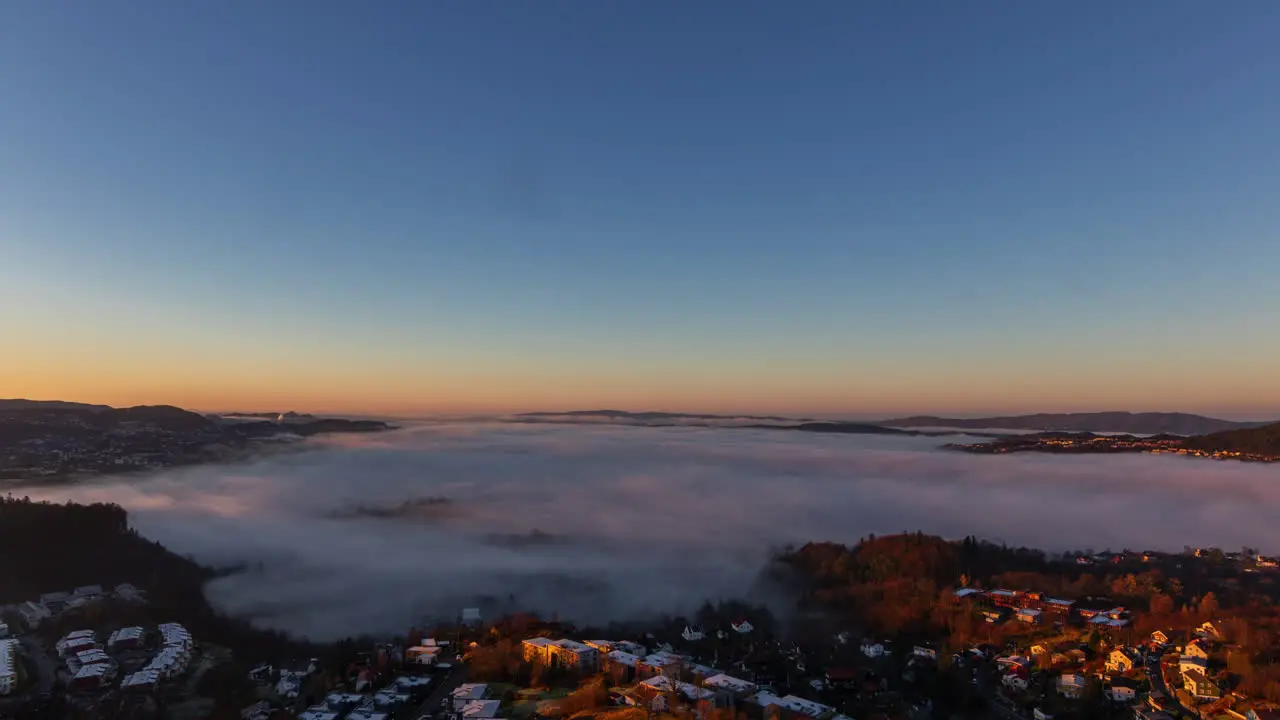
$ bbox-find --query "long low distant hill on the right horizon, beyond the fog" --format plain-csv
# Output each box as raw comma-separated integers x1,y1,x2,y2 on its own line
877,411,1266,436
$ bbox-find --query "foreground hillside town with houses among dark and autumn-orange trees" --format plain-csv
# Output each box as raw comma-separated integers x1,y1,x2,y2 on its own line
0,500,1280,720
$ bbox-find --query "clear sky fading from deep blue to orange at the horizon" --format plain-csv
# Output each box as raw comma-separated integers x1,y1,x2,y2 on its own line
0,0,1280,415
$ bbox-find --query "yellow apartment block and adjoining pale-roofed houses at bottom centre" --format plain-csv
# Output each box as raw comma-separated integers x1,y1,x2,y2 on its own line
514,628,847,720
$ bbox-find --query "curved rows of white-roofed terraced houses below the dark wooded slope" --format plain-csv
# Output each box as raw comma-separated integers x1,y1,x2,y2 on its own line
54,623,196,692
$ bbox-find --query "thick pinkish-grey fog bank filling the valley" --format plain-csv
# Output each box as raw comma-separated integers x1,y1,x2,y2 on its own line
20,423,1280,639
